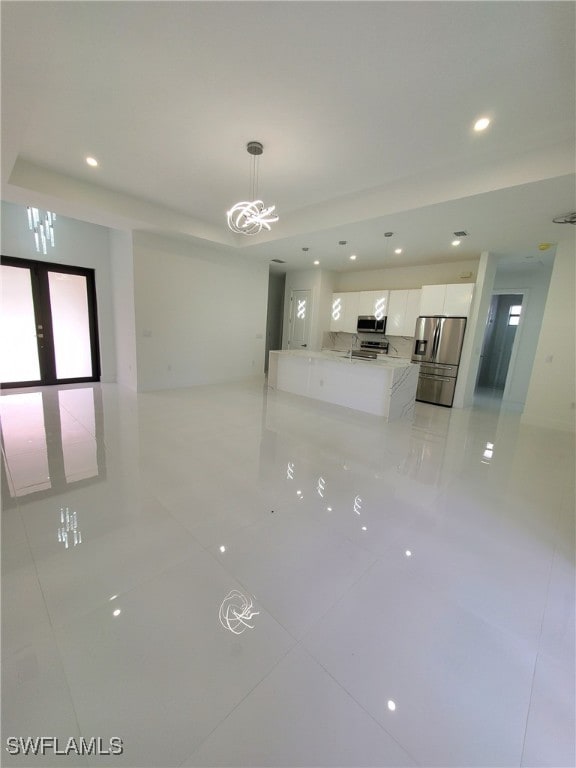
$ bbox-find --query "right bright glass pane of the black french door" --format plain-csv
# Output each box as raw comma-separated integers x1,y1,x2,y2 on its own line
48,272,93,379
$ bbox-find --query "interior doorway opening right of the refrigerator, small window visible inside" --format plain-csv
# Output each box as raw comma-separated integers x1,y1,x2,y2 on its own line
475,293,525,399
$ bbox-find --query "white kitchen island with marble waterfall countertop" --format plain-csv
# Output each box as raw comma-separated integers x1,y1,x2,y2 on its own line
268,350,420,421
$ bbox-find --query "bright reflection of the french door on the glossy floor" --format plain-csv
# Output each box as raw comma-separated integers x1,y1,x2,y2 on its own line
0,387,105,498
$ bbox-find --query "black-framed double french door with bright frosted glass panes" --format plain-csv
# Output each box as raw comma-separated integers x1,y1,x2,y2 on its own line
0,256,100,387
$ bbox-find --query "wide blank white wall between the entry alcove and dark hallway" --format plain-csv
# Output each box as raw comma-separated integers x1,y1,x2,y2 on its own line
133,232,268,391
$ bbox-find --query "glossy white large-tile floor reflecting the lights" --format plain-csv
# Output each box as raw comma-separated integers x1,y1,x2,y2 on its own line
0,382,575,768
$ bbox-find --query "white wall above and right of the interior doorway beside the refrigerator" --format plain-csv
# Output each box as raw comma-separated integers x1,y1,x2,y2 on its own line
494,265,552,406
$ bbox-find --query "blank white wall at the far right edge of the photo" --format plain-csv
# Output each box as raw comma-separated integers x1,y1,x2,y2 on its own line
522,241,576,431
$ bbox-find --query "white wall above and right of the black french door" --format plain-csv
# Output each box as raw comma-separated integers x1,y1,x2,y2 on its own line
2,201,116,382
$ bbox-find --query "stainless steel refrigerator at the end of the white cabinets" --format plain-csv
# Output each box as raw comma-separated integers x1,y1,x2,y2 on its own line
412,317,466,408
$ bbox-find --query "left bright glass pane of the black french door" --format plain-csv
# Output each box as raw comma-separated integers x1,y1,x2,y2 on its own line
0,264,40,383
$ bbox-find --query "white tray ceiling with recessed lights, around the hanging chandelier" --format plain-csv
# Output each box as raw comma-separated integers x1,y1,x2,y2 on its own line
1,0,576,270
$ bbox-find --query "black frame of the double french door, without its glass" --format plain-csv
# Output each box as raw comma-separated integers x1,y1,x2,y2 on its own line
0,255,100,389
